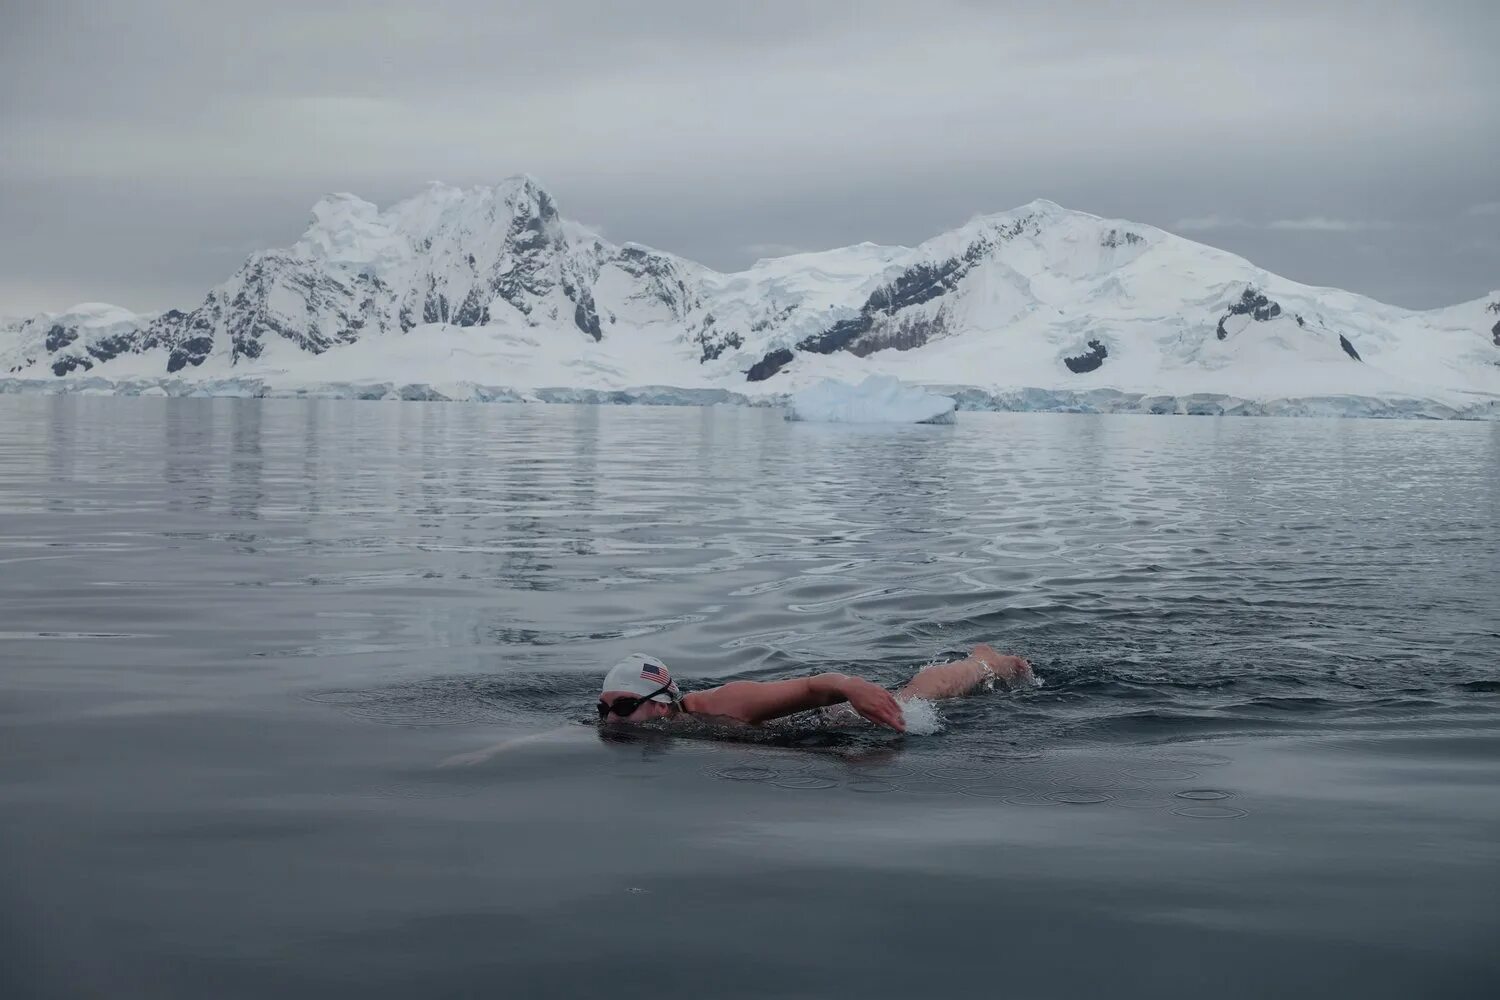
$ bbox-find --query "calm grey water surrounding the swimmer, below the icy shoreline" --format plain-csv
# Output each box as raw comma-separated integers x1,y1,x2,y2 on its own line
0,397,1500,1000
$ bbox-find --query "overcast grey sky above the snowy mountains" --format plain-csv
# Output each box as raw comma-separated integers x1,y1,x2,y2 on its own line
0,0,1500,313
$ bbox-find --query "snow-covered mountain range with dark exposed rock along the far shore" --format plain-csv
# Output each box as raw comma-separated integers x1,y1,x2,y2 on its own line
0,177,1500,415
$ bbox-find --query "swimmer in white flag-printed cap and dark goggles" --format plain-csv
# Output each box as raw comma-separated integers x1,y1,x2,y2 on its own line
599,645,1032,733
